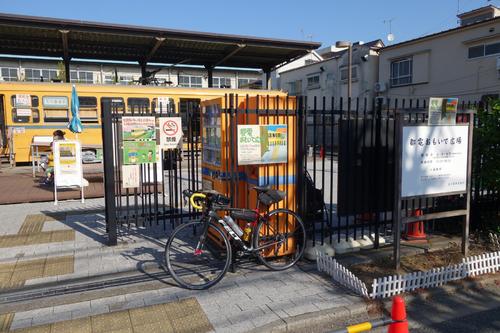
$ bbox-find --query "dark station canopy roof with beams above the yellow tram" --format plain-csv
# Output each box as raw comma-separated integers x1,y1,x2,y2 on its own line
0,13,320,70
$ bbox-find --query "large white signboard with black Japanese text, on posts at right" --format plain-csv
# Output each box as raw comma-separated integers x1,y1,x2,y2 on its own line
401,126,469,198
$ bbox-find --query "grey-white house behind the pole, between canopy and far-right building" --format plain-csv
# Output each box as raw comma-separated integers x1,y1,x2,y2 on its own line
279,39,384,108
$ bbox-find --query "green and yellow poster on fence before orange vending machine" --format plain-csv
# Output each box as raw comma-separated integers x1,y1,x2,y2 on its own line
238,124,288,165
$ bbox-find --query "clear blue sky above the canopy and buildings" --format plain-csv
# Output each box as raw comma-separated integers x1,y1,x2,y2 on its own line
0,0,500,46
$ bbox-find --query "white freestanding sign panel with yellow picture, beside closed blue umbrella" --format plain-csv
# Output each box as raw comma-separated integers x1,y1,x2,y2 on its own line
53,140,83,187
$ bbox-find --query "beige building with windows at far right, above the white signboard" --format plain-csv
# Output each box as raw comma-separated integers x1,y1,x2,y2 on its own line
379,6,500,102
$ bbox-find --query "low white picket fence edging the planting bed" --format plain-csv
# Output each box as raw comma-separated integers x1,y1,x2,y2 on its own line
317,251,500,299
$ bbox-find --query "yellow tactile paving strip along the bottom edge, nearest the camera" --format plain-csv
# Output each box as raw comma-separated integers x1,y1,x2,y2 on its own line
0,298,213,333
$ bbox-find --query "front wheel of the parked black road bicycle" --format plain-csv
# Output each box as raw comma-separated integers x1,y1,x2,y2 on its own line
165,221,232,290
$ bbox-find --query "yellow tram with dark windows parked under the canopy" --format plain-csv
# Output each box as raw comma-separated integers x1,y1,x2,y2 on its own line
0,82,286,163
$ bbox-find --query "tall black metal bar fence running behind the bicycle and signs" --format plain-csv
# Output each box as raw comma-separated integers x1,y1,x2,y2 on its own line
102,95,500,246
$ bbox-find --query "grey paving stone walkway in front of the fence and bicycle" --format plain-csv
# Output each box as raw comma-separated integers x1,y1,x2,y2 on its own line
0,199,362,333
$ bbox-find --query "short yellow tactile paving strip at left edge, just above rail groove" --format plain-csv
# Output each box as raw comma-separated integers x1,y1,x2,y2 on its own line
0,256,75,289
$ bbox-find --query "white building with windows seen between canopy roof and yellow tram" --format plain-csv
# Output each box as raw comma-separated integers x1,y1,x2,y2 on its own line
0,57,262,89
